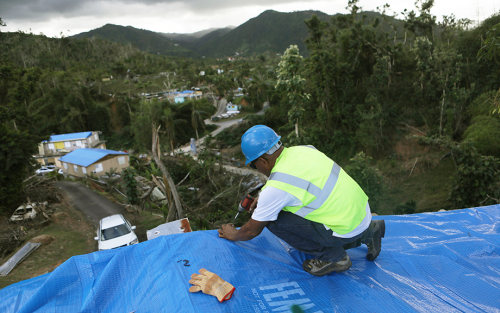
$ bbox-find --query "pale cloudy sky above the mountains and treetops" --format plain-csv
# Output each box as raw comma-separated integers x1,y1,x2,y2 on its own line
0,0,500,37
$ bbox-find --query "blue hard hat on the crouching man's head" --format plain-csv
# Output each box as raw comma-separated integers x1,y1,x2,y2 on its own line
241,125,281,165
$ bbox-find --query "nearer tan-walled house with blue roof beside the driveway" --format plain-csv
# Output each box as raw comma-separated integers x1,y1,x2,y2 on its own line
59,148,130,177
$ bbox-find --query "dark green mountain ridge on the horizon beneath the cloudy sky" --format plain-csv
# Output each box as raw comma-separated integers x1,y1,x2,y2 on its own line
71,10,398,58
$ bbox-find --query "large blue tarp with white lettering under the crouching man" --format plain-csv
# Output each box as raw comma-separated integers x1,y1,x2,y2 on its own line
0,205,500,313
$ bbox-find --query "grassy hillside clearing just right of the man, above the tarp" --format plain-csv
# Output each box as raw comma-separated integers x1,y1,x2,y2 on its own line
379,158,456,215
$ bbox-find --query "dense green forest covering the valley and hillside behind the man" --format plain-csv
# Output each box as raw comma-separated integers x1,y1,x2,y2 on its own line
0,0,500,216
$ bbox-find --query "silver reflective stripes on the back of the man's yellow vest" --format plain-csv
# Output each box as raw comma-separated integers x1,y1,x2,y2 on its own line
269,163,340,217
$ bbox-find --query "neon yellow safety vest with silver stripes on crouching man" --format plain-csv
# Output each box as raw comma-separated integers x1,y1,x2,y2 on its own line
263,146,368,235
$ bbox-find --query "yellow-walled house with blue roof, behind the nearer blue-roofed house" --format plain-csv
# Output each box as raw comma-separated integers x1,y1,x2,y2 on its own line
36,131,106,167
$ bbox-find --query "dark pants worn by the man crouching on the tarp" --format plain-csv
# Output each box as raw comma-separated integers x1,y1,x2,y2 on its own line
266,211,373,262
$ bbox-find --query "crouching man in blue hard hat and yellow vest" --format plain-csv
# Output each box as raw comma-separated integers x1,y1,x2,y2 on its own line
218,125,385,276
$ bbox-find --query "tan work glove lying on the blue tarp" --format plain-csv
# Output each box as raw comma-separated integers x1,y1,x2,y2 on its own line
189,268,235,302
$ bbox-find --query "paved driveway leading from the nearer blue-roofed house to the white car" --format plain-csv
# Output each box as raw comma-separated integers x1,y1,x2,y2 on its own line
55,181,127,227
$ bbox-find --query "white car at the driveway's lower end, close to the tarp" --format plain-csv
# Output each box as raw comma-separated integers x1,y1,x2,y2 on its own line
94,214,139,251
